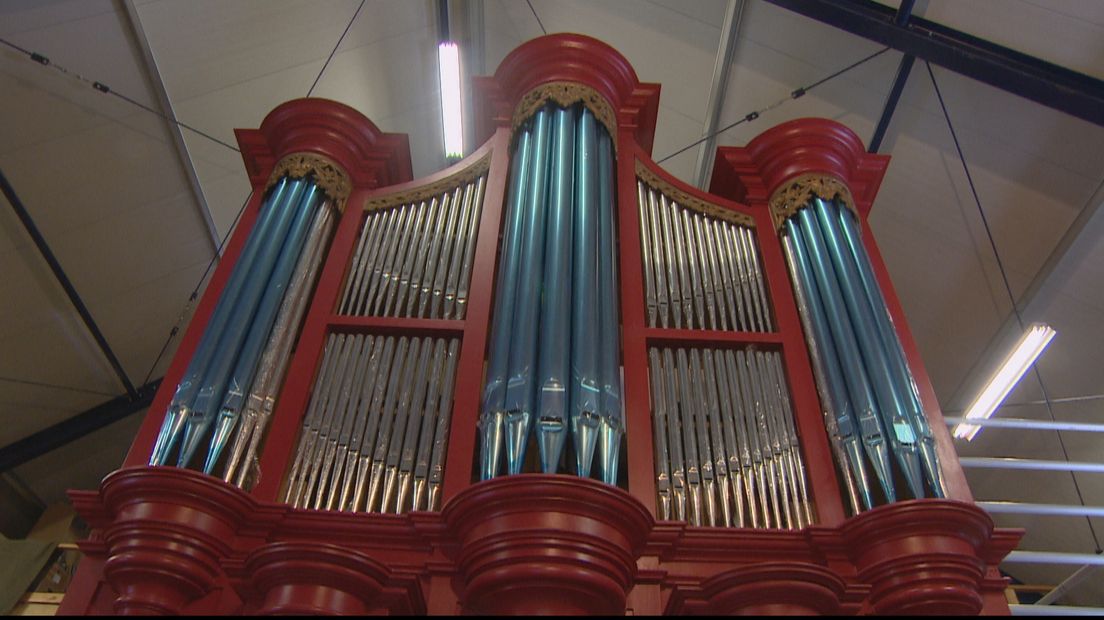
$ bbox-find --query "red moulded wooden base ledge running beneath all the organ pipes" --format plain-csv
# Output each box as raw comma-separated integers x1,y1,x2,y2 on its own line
66,467,1022,614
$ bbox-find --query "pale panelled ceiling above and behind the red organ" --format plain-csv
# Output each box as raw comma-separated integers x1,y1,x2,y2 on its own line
0,0,1104,605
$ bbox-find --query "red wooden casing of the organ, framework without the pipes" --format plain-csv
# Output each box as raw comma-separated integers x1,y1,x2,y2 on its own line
61,34,1021,614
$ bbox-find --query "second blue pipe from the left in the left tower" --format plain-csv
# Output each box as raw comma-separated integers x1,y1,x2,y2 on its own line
177,183,317,467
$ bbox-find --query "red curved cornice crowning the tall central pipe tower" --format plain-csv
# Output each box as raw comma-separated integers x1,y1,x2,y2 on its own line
473,34,659,153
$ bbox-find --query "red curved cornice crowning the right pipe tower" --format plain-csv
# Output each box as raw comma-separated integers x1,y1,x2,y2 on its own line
709,118,890,216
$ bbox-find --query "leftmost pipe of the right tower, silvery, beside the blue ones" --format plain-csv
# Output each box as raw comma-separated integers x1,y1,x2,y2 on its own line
783,226,874,510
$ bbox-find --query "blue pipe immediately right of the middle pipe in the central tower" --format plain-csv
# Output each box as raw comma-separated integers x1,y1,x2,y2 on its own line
574,107,604,478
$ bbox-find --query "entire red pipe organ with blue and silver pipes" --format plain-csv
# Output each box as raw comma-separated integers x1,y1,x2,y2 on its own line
62,34,1022,614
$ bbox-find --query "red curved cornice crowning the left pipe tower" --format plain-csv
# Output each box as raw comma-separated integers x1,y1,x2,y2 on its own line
234,97,413,189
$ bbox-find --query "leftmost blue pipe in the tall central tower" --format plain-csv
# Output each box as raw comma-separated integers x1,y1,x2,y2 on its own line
479,127,533,480
